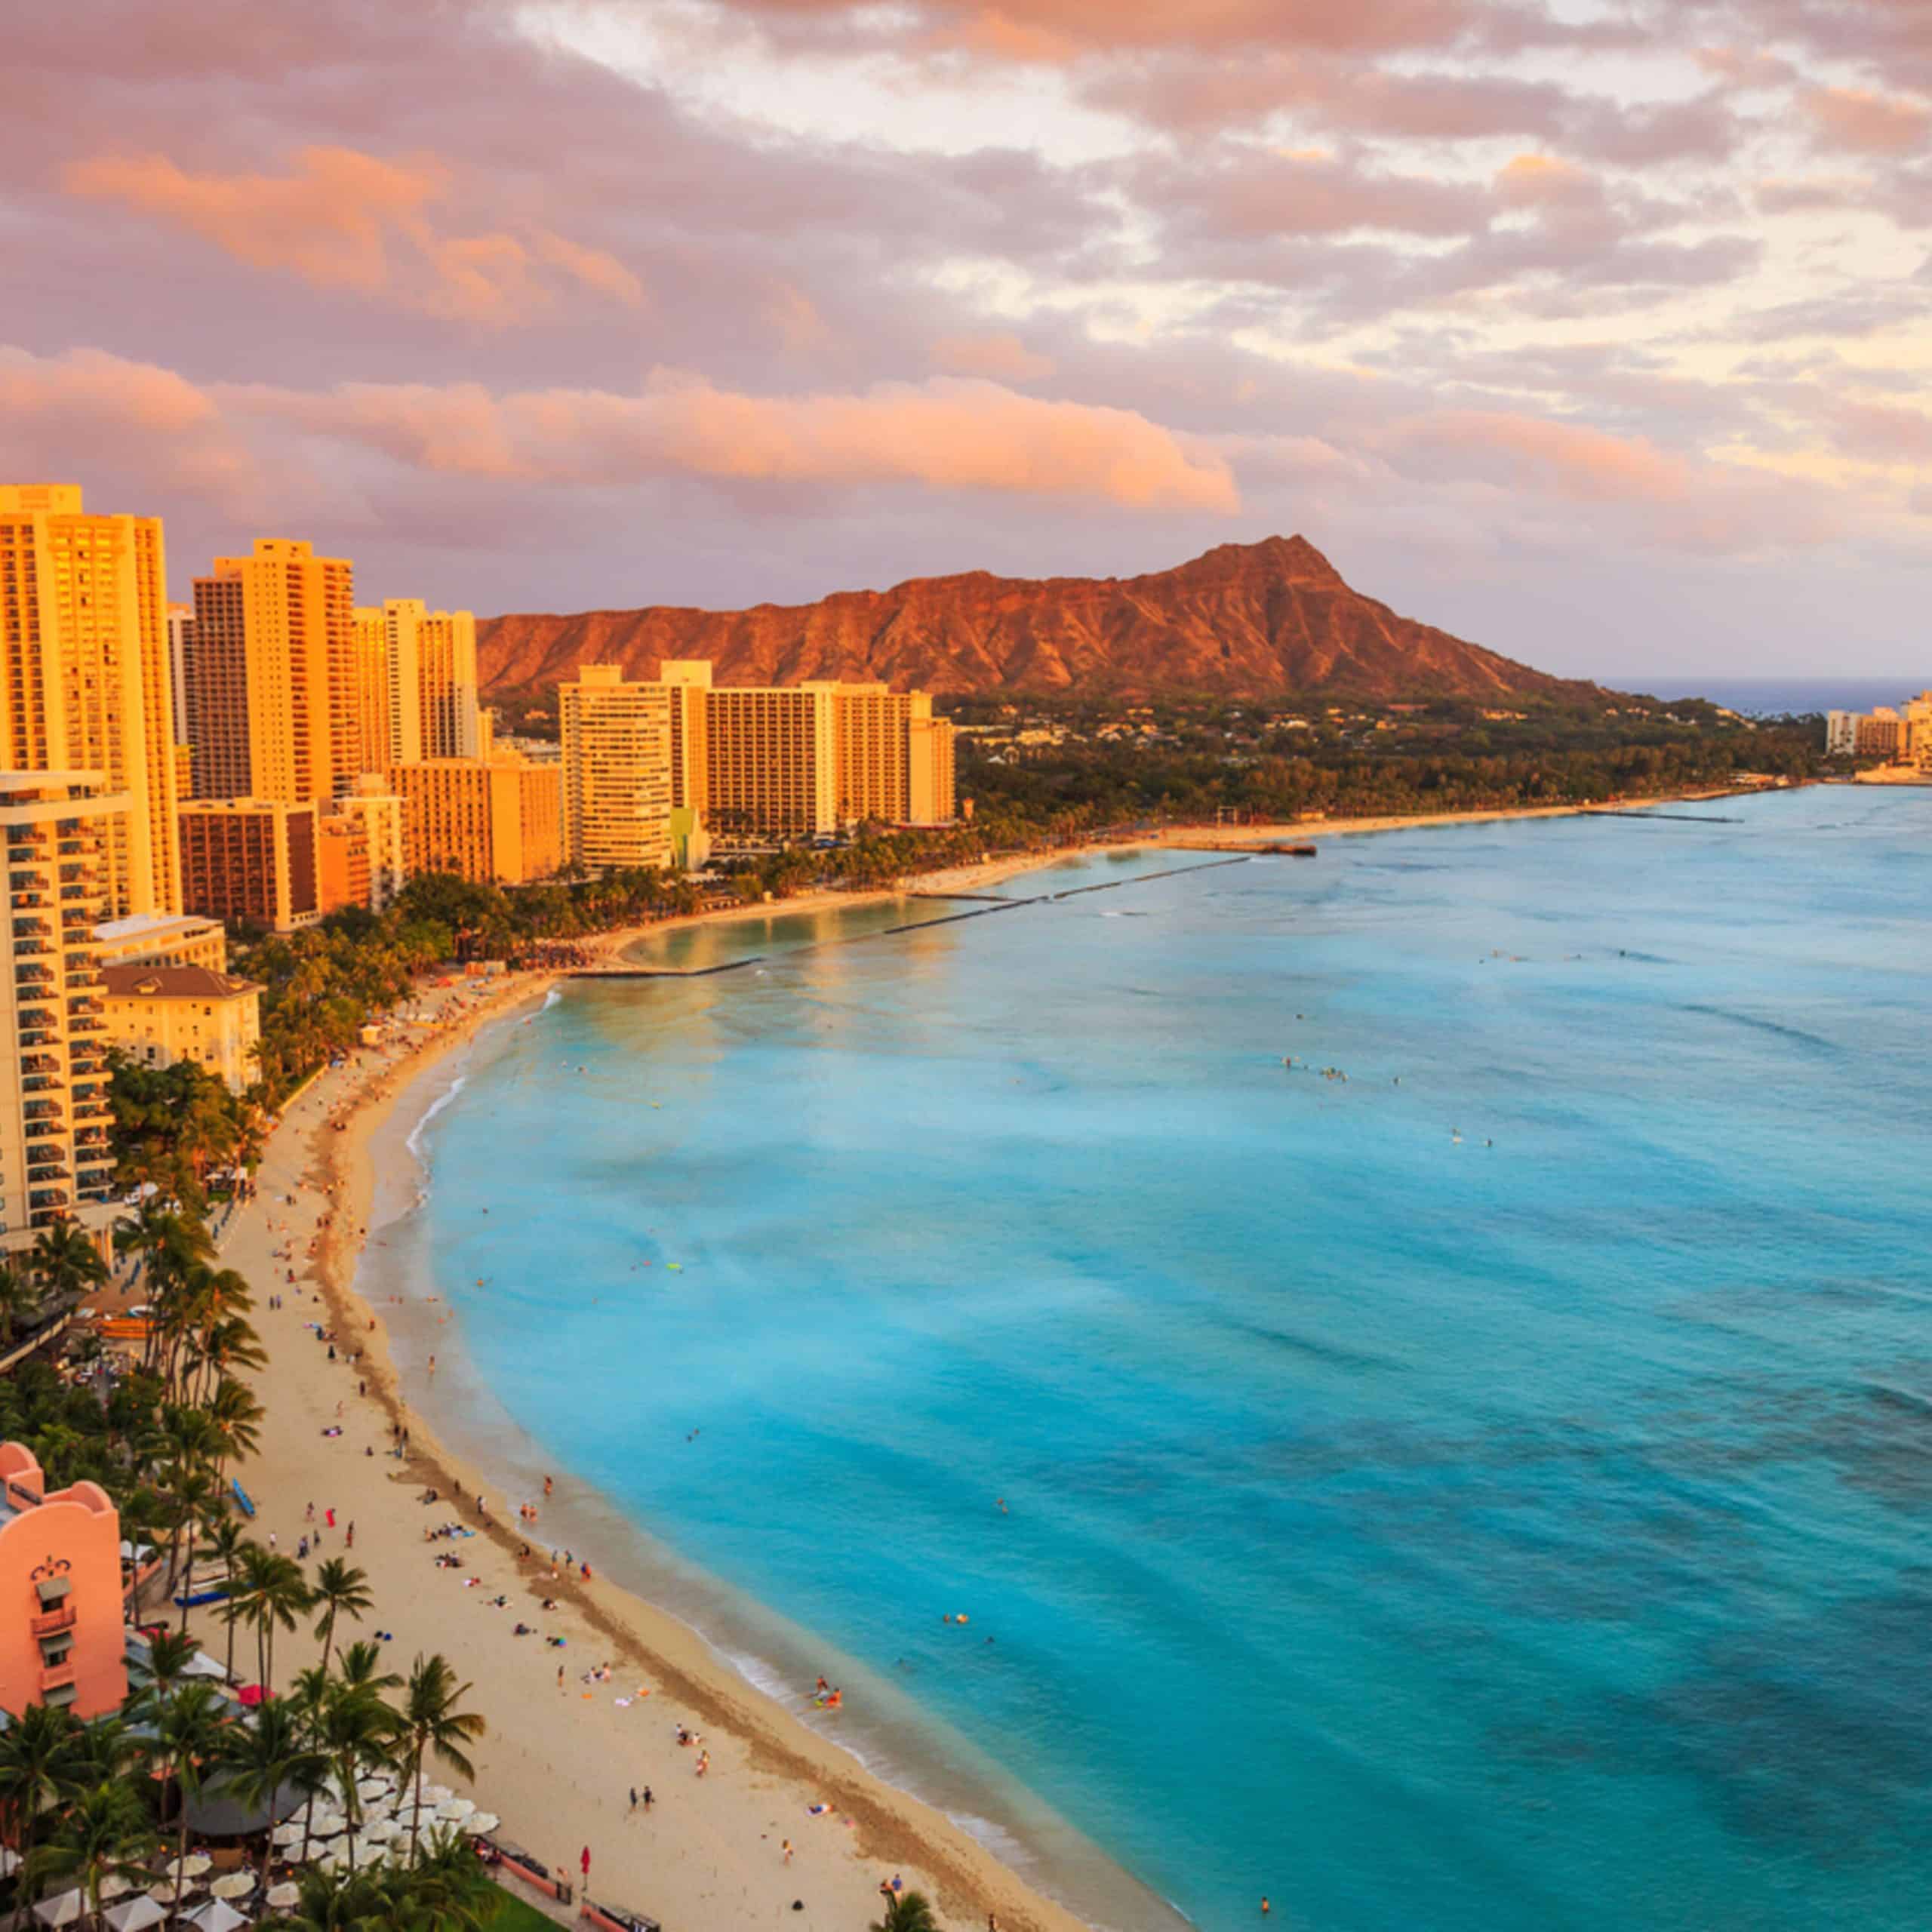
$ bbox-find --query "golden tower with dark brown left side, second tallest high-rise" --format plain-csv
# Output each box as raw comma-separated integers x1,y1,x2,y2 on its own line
187,537,358,804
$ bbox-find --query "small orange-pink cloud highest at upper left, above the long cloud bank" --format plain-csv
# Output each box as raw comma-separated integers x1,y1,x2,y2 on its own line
62,147,643,325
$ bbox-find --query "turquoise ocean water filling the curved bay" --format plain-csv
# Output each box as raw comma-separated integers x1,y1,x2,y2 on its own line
399,788,1932,1932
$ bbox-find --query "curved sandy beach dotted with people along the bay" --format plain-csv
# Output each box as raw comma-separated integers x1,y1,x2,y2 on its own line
184,788,1777,1932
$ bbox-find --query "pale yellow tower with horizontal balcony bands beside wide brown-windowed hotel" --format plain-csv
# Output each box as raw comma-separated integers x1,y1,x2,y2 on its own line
556,665,684,867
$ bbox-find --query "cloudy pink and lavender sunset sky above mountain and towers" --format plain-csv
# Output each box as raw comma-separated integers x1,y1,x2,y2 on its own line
0,0,1932,682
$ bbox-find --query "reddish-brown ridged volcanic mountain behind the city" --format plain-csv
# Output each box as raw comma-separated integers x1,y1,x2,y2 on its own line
477,537,1600,701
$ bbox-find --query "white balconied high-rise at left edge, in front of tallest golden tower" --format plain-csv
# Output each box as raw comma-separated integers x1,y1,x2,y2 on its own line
0,771,121,1248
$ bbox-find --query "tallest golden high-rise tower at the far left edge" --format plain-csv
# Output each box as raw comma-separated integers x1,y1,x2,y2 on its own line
0,483,182,918
